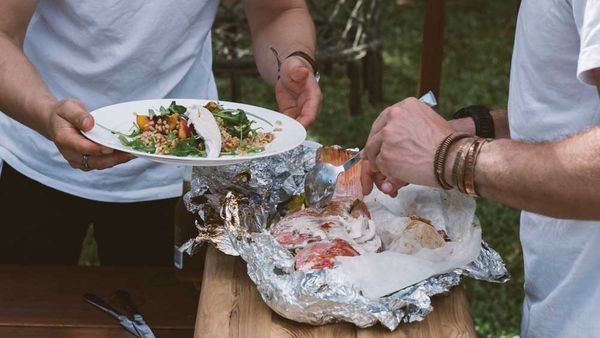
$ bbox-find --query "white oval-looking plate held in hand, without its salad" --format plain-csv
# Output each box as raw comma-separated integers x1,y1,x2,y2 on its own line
83,99,306,166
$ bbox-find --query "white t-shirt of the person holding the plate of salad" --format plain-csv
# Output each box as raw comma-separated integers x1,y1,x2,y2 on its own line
0,0,218,202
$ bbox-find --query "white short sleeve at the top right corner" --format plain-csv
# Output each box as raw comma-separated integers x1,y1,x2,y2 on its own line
572,0,600,86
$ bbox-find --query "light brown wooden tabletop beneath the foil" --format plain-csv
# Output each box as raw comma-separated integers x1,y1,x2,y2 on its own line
194,247,476,338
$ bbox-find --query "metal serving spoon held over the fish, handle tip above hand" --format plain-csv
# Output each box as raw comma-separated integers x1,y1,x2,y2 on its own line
304,91,437,210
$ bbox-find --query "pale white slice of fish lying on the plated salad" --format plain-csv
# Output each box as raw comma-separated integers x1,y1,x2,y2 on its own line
188,106,222,158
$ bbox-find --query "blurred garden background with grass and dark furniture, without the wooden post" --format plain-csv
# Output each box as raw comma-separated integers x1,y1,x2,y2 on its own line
80,0,523,337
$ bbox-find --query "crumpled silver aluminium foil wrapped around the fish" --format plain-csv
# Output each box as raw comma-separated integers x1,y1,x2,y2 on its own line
183,145,509,330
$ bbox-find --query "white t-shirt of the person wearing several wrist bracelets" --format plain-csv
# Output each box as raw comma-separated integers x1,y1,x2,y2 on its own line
508,0,600,338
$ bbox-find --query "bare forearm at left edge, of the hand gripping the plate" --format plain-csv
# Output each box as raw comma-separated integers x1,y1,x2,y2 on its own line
0,32,56,137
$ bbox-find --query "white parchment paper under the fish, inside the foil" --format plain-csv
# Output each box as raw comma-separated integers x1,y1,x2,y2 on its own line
337,185,481,298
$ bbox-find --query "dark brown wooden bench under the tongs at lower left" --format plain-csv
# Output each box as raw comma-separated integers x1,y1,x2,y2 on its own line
0,265,198,338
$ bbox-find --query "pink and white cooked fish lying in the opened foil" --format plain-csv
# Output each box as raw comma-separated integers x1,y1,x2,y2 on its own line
270,146,382,271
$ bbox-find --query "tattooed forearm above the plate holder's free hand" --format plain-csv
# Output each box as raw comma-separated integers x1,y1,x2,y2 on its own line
244,0,316,84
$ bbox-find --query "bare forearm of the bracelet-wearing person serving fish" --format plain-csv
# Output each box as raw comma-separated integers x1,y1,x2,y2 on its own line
475,127,600,219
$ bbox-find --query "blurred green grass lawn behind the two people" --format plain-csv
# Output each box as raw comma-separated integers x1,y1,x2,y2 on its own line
217,0,523,337
